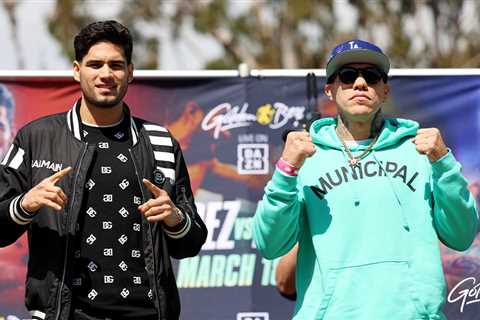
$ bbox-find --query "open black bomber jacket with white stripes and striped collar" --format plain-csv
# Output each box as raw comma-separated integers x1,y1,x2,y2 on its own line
0,102,207,320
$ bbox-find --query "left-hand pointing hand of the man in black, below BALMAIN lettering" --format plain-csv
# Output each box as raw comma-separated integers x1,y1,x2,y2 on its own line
20,167,72,213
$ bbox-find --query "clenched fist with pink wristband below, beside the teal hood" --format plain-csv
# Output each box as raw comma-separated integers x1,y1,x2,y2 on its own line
282,131,315,168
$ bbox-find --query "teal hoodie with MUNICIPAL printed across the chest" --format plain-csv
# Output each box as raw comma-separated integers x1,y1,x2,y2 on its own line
254,118,478,320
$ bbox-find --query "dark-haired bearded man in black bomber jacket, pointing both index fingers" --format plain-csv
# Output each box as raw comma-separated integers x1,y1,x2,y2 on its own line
0,21,207,319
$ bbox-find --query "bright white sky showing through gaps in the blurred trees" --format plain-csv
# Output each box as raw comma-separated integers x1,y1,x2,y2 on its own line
0,0,472,70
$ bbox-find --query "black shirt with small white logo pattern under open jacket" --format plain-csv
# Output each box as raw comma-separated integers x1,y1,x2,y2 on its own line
72,119,157,319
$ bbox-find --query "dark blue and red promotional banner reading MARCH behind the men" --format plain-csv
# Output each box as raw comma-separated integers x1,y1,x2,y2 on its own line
0,76,480,320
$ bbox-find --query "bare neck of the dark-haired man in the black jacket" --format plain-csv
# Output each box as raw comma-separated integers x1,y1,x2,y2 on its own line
80,99,123,126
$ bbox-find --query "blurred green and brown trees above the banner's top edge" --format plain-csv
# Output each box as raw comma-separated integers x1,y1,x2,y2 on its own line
49,0,480,69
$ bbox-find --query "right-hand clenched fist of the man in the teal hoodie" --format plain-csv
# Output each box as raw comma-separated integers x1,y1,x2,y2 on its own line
412,128,448,162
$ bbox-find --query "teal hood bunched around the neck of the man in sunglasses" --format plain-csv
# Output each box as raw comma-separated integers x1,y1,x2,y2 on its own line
310,118,419,150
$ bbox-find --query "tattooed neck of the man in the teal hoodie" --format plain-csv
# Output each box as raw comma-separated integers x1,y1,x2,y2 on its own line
336,112,382,141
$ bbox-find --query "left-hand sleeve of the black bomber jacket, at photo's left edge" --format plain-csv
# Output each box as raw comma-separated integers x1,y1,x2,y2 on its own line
0,131,34,247
